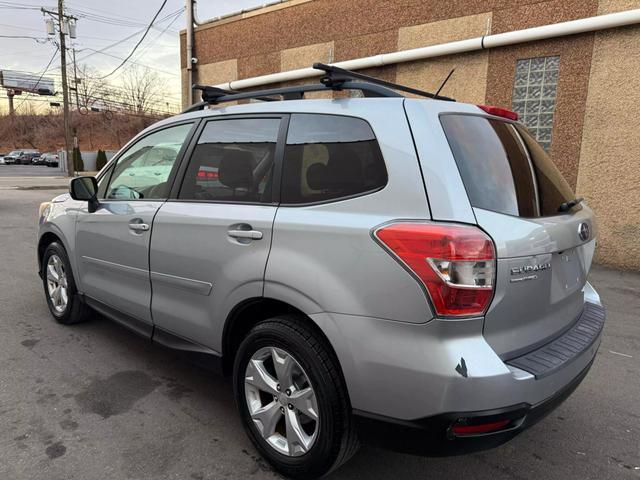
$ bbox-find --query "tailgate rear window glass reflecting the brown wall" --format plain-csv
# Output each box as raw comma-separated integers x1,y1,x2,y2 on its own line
440,115,575,218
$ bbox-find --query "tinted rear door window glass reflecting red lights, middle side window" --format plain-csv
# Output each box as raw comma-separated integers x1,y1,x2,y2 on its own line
178,118,280,203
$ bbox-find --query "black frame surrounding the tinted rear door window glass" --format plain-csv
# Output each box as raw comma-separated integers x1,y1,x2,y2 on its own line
167,113,291,206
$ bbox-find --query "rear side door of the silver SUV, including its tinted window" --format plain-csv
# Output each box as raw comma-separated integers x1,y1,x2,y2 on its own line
150,115,287,352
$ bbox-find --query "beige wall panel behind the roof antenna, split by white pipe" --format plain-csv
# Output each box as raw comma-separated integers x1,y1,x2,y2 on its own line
396,13,492,103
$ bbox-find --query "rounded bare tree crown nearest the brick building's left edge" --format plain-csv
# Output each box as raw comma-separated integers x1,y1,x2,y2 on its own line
120,65,166,113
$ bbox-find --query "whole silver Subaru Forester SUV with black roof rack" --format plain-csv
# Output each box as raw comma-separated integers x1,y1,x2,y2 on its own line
38,66,605,478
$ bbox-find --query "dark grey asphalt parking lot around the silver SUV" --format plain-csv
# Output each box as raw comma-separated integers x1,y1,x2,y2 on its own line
0,174,640,480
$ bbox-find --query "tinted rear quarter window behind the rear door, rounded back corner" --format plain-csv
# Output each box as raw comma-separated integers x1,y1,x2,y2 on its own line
281,114,387,204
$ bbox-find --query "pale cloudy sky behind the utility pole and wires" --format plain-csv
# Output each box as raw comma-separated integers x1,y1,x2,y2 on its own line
0,0,266,113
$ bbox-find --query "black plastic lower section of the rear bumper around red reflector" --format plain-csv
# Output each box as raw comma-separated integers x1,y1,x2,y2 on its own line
353,354,593,457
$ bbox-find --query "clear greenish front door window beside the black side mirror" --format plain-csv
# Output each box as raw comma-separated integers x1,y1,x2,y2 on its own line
105,123,193,200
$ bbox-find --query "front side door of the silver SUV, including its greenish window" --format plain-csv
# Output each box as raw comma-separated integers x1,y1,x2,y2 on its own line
76,123,193,334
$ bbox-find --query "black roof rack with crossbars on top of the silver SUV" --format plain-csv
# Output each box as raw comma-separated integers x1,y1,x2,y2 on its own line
182,63,455,113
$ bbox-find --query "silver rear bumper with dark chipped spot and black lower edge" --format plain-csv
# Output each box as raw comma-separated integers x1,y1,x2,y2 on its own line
311,284,604,448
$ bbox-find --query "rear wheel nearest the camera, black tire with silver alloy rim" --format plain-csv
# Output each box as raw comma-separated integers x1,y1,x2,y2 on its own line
233,315,358,478
